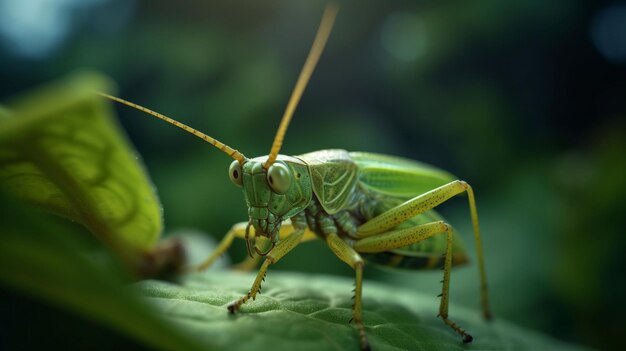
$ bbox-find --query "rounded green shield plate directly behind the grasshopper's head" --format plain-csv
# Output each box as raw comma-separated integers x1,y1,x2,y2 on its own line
298,150,357,214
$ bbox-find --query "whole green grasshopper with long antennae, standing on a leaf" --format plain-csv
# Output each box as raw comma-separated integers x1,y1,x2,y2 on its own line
101,4,491,350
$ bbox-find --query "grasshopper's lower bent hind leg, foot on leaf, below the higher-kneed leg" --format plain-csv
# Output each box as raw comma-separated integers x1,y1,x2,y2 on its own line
354,221,473,343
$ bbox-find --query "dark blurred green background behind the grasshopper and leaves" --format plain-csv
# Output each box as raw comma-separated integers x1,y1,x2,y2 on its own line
0,0,626,349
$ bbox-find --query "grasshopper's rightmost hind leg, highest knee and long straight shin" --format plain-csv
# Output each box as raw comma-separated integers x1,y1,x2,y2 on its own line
357,180,491,319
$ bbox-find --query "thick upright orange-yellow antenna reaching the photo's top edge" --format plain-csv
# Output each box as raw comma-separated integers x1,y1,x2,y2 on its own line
263,3,339,169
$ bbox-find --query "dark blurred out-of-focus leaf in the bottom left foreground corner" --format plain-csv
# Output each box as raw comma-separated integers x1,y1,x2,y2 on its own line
0,194,202,350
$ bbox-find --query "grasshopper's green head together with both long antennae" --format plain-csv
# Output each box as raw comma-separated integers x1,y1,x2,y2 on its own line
99,3,338,256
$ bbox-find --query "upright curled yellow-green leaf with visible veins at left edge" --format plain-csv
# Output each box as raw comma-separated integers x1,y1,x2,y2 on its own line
0,74,162,263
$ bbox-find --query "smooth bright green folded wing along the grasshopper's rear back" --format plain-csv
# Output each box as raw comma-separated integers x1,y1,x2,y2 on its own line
349,152,458,198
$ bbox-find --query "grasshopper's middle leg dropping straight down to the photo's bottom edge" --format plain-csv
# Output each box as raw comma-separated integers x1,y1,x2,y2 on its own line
326,233,370,350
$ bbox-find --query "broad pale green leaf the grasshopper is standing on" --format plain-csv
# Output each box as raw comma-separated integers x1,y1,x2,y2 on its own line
133,270,577,351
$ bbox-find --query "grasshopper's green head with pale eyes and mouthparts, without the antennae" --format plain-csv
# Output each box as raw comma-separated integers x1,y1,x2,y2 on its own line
228,155,313,255
